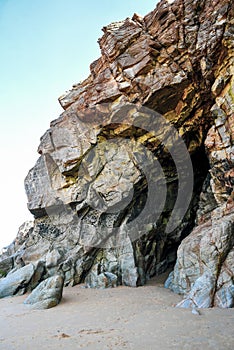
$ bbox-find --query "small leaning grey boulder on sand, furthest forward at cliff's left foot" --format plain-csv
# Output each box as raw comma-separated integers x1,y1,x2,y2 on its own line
24,275,64,309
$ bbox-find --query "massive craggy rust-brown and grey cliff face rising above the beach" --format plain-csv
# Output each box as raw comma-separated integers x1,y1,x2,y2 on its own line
0,0,234,307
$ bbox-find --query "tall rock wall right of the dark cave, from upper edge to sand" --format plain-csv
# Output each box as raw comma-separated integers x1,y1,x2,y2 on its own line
166,17,234,307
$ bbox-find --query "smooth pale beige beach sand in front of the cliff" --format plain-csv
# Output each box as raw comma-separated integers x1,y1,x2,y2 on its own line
0,276,234,350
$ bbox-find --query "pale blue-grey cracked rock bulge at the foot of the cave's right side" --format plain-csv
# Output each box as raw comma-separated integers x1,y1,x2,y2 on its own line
169,212,234,308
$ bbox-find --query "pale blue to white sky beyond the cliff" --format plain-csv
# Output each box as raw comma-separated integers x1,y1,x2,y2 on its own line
0,0,158,249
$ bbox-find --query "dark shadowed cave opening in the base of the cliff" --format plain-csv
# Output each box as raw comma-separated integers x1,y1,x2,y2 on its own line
133,145,210,285
